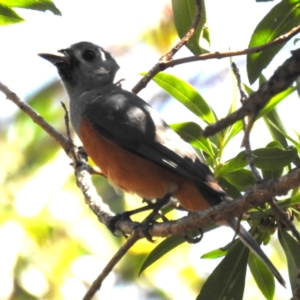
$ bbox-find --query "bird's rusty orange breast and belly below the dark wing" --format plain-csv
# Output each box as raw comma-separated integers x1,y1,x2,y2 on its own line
79,118,209,211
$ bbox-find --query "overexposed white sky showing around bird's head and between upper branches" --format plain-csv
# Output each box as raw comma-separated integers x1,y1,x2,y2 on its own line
0,0,299,295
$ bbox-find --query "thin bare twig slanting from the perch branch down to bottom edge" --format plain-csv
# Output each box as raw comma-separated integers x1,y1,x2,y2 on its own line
82,232,141,300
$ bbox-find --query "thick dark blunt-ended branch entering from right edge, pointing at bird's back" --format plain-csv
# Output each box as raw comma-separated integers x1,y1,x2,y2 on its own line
203,49,300,137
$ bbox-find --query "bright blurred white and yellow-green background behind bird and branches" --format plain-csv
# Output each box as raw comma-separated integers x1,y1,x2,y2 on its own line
0,0,299,300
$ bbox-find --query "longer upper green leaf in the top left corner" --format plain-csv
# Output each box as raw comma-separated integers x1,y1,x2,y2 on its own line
0,0,61,16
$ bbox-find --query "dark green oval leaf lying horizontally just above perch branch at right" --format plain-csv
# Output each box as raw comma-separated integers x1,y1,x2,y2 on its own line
252,147,297,171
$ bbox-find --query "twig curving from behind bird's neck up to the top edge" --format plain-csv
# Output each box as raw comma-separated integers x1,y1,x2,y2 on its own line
131,0,201,94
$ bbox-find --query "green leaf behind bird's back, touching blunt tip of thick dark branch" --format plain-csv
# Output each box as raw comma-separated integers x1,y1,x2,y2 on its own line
170,122,215,158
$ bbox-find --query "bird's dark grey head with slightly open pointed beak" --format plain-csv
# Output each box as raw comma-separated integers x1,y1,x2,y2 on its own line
39,42,119,92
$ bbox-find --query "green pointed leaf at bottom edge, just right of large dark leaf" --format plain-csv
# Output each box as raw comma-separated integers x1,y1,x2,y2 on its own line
248,252,275,300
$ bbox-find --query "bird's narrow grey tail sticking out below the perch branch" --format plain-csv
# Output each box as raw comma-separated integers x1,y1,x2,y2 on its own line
227,219,285,287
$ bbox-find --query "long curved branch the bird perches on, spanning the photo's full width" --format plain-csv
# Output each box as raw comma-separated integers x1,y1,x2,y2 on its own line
0,83,300,238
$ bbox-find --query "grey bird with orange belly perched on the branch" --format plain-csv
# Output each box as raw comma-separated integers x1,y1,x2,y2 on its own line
39,42,285,286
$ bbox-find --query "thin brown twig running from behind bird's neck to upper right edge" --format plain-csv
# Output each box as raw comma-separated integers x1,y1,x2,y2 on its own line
132,26,300,94
